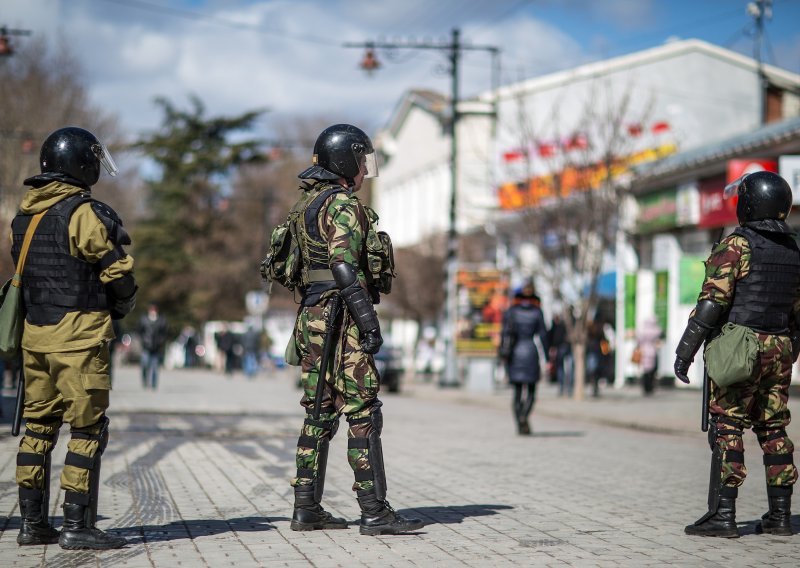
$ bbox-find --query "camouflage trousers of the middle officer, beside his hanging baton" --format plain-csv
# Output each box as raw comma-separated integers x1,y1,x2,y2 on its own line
292,299,382,491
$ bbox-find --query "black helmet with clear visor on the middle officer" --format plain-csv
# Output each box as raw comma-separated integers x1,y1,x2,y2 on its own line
298,124,378,181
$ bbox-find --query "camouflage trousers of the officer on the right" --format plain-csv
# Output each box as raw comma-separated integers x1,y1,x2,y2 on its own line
710,333,797,487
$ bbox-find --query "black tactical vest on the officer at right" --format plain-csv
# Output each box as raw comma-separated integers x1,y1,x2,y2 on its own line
728,227,800,334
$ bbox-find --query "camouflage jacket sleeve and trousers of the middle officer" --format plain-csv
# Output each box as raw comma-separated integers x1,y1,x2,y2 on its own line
292,184,382,491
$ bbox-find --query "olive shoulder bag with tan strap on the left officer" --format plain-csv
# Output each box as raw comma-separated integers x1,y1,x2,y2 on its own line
0,210,47,360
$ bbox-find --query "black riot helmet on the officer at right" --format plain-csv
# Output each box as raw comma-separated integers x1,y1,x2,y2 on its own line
725,171,792,224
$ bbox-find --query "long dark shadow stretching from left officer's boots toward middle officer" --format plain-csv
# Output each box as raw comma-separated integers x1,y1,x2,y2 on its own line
115,517,289,544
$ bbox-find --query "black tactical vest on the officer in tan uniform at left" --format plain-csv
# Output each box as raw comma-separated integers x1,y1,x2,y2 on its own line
11,193,108,325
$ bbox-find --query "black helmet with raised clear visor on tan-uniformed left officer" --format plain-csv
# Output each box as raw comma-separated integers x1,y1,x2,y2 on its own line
39,126,117,187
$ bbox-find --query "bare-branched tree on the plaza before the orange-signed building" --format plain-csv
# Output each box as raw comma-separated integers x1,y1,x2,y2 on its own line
500,79,664,400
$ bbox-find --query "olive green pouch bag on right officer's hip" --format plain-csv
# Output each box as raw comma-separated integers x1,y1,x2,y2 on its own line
705,322,759,387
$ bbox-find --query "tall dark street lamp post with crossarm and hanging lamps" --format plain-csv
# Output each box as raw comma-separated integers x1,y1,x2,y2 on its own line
344,28,500,386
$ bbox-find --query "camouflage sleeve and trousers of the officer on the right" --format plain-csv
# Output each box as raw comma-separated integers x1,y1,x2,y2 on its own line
698,234,800,487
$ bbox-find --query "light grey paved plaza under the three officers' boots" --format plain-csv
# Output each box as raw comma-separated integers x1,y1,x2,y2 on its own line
0,368,800,568
